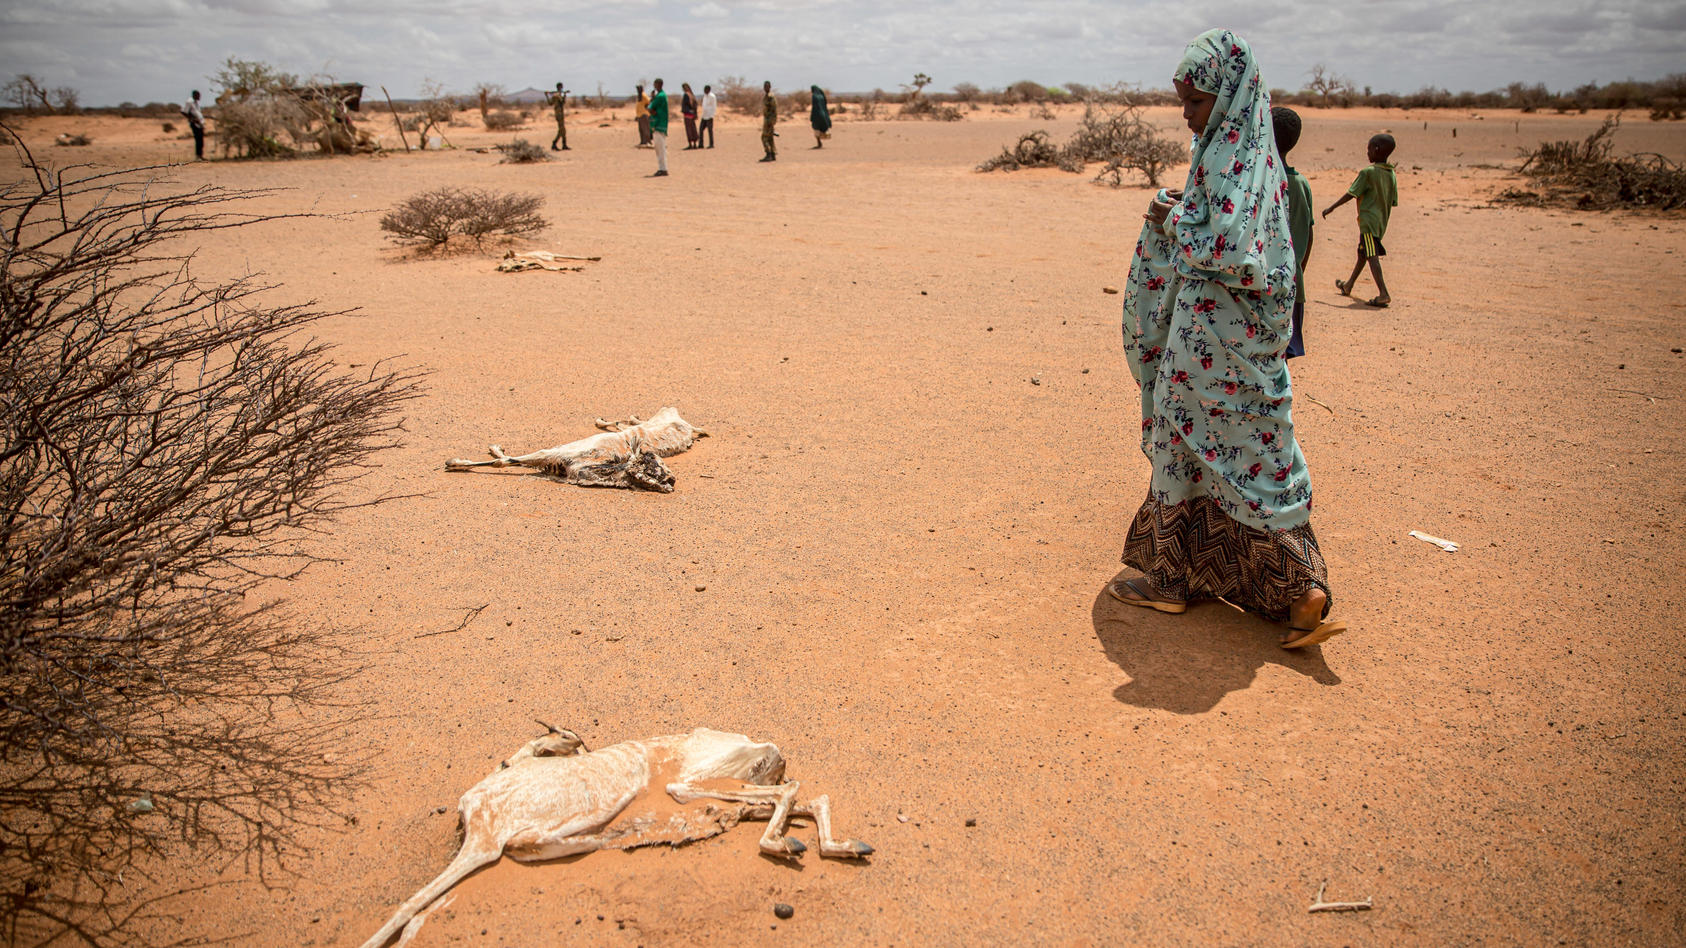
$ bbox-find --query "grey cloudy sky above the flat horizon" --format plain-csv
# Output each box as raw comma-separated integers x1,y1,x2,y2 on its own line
0,0,1686,105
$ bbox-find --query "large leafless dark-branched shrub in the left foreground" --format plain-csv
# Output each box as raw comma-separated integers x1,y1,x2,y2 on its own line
0,127,416,945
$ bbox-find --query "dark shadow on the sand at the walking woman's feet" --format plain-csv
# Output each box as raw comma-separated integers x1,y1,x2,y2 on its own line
1091,572,1340,714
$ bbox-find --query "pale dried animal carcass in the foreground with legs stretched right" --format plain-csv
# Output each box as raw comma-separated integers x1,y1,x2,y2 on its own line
362,722,872,948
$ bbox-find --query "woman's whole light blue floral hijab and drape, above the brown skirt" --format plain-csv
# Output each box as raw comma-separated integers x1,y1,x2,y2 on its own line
1123,30,1312,530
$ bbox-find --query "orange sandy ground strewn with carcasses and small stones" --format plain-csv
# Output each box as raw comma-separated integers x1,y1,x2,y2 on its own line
7,108,1686,946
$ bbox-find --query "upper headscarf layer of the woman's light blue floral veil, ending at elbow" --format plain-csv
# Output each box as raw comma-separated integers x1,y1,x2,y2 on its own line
1165,30,1293,292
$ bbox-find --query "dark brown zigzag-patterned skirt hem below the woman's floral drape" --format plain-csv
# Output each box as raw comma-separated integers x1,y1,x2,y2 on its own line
1125,496,1335,622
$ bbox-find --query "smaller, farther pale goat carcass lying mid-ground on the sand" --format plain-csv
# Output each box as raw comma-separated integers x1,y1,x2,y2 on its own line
445,408,708,494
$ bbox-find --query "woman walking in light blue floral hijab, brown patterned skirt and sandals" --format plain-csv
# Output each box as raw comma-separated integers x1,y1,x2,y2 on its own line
1108,30,1345,648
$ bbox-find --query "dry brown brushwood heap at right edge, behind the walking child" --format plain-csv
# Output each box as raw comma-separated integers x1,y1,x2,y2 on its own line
1499,116,1686,211
